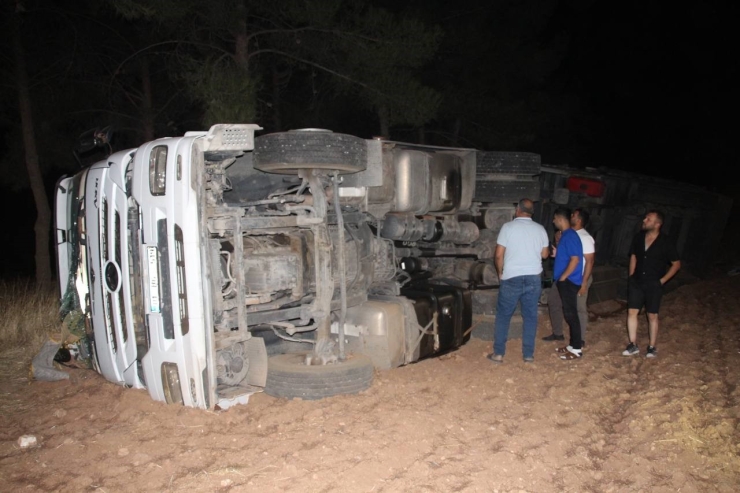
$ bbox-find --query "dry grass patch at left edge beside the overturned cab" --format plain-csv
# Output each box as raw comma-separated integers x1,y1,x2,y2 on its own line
0,280,62,362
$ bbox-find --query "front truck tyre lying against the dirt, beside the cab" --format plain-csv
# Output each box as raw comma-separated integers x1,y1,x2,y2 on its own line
265,352,373,400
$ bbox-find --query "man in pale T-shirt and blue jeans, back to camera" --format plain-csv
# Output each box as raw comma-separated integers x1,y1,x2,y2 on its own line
487,199,549,363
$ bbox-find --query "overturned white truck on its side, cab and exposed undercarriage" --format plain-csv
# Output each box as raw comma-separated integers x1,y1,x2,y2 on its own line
56,124,540,409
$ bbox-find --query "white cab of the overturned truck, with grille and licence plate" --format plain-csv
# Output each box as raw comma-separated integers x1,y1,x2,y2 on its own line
56,125,266,408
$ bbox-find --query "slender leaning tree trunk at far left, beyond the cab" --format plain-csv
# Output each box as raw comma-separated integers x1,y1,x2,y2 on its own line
11,6,52,288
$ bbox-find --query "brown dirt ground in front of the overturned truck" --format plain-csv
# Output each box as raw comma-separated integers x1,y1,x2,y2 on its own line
0,276,740,492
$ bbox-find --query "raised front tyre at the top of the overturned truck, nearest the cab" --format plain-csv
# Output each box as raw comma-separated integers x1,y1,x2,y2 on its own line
253,129,367,174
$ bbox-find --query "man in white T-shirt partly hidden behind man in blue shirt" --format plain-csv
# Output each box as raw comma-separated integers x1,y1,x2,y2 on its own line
542,209,596,342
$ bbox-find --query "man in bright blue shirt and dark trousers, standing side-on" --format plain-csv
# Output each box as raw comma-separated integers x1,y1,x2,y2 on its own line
552,208,583,360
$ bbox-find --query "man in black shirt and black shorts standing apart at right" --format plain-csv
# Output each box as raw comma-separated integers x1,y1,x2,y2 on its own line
622,211,681,358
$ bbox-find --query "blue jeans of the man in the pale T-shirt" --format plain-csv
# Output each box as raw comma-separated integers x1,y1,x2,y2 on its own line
493,274,542,358
